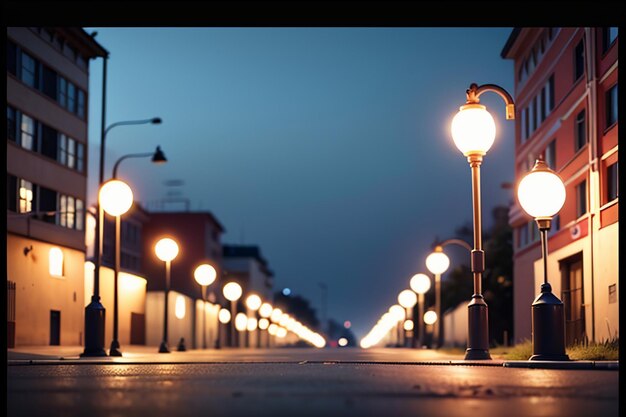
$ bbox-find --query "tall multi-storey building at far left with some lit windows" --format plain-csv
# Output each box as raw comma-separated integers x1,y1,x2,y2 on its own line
6,27,108,347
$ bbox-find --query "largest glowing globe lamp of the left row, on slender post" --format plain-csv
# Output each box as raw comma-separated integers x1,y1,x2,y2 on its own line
98,179,133,356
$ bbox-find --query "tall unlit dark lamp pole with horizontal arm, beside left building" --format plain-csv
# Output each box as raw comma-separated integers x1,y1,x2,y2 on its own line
81,115,161,356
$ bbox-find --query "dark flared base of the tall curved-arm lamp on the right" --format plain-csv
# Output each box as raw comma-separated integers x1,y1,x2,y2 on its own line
465,294,491,360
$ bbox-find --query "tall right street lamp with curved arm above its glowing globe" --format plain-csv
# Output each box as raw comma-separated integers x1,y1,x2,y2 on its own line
452,84,515,360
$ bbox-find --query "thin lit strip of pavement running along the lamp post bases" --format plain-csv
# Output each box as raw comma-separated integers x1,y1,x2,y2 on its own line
7,345,619,370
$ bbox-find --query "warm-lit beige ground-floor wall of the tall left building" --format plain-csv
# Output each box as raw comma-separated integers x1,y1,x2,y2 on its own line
7,234,85,346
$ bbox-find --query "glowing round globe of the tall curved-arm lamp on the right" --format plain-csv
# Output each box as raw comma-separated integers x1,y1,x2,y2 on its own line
452,104,496,156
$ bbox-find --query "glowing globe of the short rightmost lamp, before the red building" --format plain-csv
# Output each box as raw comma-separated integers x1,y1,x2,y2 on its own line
517,160,565,218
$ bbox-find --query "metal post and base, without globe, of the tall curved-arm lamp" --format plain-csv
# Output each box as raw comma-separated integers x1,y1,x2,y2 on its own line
460,155,491,360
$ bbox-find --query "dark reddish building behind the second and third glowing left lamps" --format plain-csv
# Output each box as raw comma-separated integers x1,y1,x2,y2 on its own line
142,212,224,350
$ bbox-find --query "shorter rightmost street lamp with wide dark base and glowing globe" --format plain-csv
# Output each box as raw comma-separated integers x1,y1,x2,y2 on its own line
517,158,569,361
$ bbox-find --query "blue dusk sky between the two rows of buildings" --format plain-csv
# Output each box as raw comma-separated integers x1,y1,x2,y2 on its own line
86,28,514,338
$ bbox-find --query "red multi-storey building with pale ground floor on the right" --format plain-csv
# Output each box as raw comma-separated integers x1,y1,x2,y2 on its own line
502,27,619,344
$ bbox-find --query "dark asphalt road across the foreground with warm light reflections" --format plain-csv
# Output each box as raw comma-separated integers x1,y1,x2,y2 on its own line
7,349,619,417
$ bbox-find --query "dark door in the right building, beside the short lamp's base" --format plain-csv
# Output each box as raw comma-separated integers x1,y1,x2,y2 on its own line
561,253,586,346
